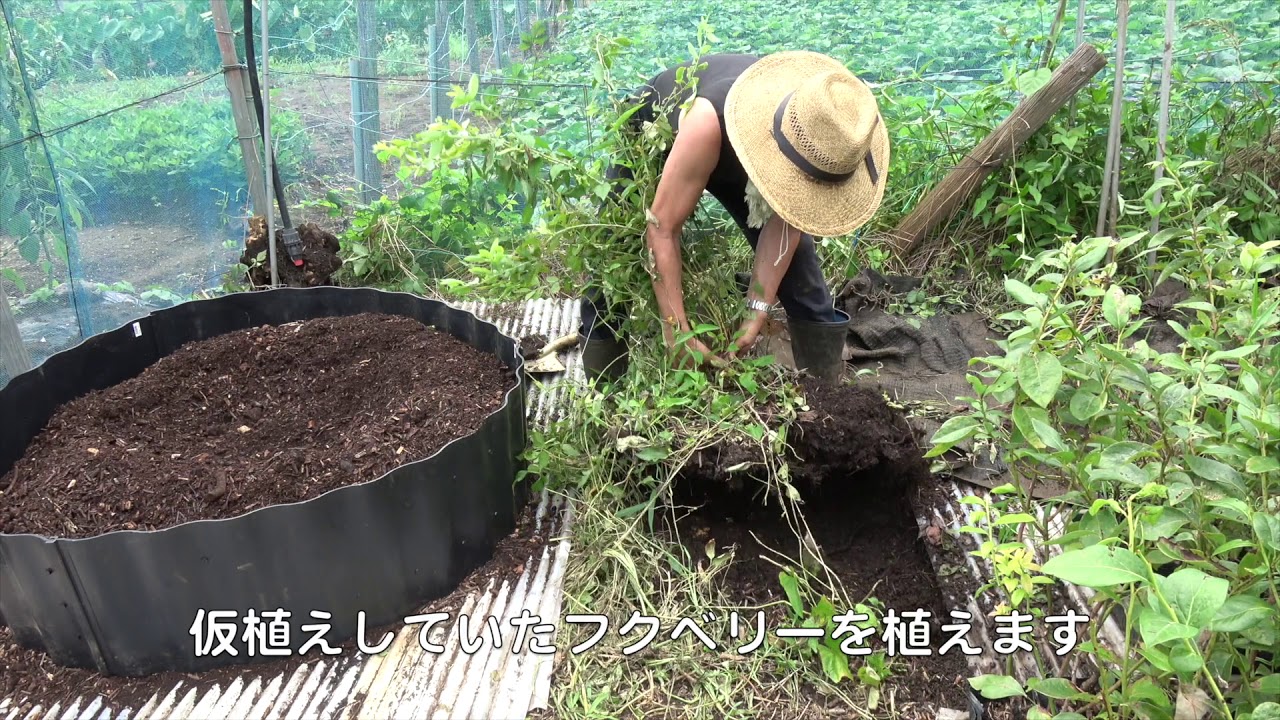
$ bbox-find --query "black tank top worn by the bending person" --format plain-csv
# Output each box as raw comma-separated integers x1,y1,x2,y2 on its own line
632,54,760,227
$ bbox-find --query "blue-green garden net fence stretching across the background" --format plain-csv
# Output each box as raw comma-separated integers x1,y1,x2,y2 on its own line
0,0,1280,382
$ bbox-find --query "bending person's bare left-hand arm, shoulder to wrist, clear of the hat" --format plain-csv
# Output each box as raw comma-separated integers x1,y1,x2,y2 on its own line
646,99,721,345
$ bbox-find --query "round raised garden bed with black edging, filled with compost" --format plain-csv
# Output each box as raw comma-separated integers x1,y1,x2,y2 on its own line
0,288,527,675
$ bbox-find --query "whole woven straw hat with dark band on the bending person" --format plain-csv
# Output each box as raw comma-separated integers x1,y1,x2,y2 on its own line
724,50,888,237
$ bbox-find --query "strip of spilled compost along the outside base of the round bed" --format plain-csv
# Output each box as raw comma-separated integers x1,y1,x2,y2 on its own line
0,505,556,717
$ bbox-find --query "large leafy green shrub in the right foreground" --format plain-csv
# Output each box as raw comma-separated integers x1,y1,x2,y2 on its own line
929,163,1280,720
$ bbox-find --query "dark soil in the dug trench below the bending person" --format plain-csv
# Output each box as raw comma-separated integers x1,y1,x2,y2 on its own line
675,384,969,717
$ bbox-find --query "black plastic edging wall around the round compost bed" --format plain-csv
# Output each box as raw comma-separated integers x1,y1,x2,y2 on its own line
0,287,530,675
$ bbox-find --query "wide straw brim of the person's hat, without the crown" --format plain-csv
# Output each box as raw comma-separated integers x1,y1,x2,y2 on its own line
724,50,890,237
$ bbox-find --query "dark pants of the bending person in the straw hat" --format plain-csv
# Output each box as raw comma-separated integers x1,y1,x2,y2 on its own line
581,165,842,340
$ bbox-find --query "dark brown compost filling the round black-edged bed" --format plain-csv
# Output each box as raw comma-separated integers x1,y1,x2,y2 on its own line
0,314,515,537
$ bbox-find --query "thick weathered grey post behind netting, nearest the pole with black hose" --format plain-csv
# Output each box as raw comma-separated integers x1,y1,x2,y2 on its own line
351,0,383,204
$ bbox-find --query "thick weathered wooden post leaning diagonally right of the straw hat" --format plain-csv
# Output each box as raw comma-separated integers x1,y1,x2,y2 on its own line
888,45,1107,258
